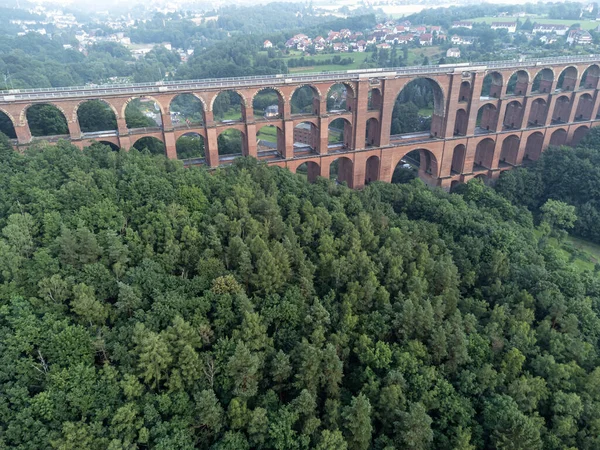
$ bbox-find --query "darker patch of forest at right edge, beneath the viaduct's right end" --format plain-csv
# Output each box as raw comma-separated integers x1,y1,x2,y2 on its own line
496,128,600,244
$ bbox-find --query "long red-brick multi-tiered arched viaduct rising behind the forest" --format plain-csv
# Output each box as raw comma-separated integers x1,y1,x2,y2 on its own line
0,55,600,189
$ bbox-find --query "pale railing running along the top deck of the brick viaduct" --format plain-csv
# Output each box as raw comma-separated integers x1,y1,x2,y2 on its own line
0,55,600,102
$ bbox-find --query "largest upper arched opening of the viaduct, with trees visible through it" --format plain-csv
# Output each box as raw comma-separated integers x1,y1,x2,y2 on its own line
391,78,444,137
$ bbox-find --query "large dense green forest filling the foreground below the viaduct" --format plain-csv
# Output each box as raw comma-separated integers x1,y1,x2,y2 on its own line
0,134,600,450
